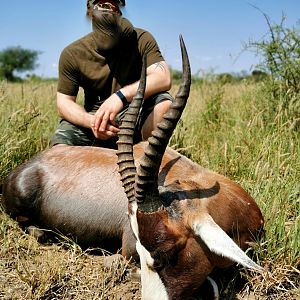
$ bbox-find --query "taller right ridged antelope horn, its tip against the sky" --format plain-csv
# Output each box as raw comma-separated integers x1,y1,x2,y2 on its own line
135,35,191,212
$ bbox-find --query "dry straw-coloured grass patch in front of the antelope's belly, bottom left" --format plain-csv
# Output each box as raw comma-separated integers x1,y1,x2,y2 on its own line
0,206,140,300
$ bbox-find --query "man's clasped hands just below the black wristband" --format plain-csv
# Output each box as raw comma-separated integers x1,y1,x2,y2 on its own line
91,94,123,140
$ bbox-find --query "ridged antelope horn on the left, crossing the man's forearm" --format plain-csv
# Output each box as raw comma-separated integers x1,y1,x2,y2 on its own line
117,55,147,203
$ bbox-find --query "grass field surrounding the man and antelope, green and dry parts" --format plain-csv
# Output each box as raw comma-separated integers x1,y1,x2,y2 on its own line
0,80,300,299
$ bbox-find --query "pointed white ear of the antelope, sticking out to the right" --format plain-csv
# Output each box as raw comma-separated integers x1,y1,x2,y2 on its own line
192,214,264,272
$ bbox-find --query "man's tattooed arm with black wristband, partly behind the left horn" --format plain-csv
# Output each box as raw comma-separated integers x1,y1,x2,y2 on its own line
93,61,171,132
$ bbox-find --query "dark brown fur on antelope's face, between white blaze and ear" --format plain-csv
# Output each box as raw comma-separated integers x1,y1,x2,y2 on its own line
138,211,214,299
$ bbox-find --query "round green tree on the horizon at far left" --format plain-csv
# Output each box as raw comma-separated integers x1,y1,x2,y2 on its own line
0,46,41,81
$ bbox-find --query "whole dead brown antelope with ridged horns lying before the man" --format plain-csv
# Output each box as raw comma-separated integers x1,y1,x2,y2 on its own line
2,36,264,300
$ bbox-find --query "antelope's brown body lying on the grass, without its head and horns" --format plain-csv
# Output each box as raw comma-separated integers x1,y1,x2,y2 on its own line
2,142,262,257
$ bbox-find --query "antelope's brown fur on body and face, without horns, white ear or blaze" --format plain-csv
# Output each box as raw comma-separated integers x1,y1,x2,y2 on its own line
2,143,263,299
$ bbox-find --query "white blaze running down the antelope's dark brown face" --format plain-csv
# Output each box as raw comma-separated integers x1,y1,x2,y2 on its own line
129,202,169,300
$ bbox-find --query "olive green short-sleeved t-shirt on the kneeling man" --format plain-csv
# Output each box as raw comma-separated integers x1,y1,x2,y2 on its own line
57,20,164,112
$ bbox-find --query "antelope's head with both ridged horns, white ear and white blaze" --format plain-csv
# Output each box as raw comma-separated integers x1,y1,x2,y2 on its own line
117,36,260,300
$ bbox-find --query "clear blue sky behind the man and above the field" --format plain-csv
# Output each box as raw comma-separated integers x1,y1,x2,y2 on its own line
0,0,300,77
